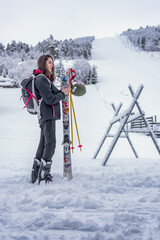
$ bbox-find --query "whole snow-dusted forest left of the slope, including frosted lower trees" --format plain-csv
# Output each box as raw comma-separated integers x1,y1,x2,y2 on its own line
0,35,98,86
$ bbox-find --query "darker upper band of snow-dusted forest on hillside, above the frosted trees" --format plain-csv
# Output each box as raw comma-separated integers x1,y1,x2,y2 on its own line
0,35,95,61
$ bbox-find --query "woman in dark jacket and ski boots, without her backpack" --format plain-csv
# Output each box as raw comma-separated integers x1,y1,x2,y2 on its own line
31,55,70,183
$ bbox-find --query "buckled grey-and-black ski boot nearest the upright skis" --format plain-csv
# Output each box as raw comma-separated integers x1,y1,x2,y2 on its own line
38,159,53,184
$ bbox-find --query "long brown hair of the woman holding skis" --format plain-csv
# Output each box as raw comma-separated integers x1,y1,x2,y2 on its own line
37,54,55,82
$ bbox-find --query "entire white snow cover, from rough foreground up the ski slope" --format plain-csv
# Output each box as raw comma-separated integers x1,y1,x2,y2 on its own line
0,38,160,240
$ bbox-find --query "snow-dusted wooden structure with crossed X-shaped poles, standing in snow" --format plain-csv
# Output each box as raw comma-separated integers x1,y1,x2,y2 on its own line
93,85,160,165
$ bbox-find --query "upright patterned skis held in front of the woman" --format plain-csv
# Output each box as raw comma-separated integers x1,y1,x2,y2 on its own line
61,70,73,180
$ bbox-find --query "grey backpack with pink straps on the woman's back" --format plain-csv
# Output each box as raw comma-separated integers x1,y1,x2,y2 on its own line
21,75,39,115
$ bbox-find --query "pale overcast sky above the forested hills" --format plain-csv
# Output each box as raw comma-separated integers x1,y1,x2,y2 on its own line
0,0,160,46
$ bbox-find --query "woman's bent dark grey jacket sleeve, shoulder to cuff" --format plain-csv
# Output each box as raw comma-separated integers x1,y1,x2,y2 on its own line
36,77,65,105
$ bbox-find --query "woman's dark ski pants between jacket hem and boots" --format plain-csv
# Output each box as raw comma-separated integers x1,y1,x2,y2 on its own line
36,120,56,161
